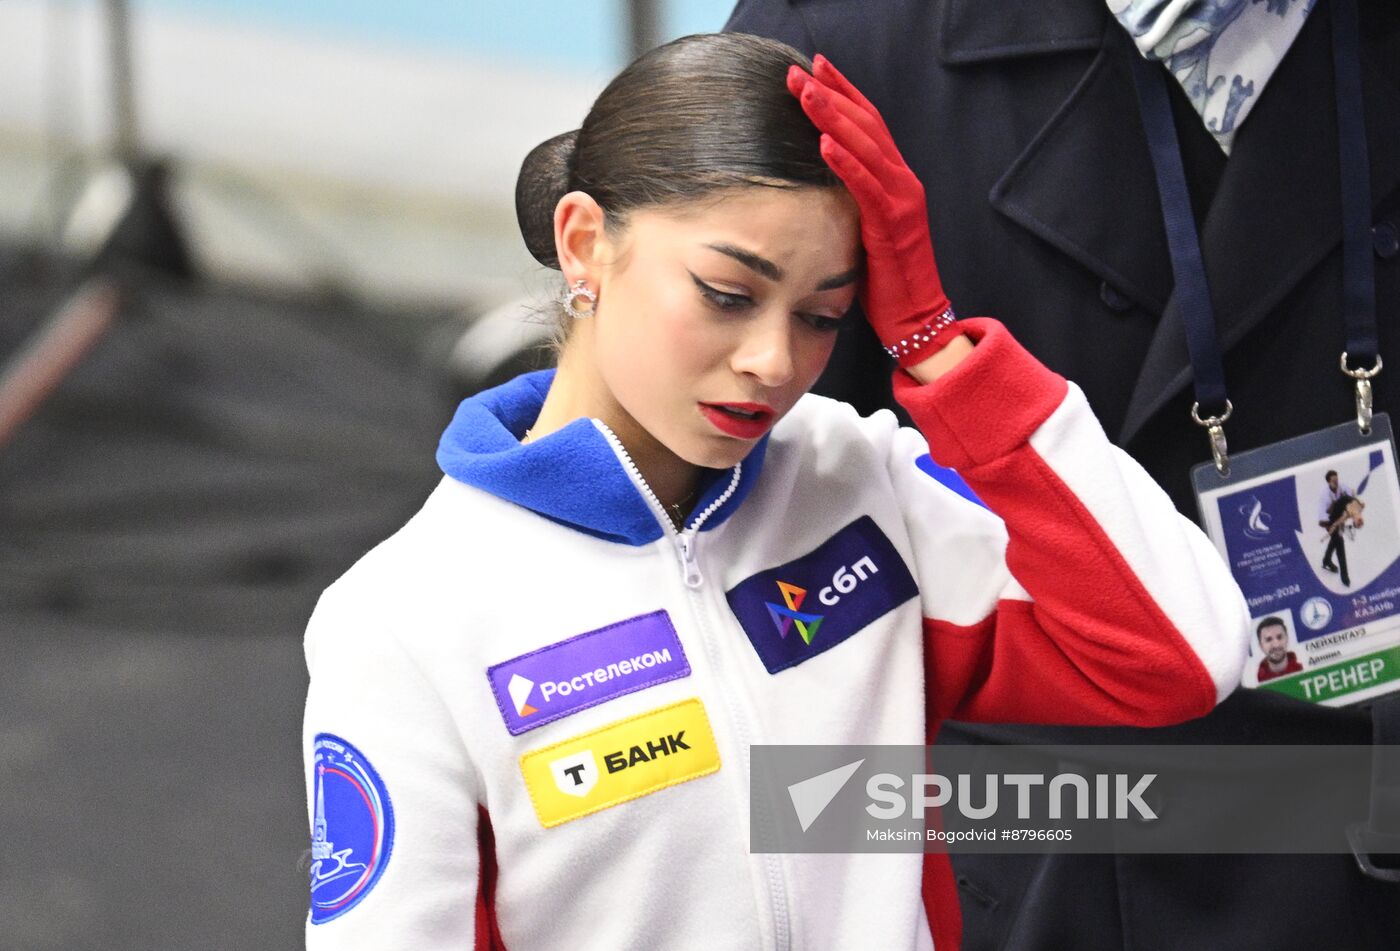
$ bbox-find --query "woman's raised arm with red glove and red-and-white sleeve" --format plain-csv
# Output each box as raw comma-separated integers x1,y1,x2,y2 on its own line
788,56,1247,726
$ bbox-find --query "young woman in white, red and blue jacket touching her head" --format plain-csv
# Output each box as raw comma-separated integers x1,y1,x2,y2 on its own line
304,35,1253,951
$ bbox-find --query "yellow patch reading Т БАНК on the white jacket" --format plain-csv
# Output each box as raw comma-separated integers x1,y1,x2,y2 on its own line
521,697,720,829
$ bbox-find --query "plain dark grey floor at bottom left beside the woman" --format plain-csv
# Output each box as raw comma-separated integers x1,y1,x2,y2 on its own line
0,616,308,951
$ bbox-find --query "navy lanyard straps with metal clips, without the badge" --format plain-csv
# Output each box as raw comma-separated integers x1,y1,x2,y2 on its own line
1130,0,1380,476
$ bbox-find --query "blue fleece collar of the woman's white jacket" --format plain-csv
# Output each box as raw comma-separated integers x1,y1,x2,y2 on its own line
437,370,769,545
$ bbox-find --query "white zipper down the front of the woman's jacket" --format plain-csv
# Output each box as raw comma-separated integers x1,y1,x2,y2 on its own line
594,419,792,951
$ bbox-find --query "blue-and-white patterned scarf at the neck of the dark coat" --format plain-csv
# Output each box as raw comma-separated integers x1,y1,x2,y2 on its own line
1107,0,1317,154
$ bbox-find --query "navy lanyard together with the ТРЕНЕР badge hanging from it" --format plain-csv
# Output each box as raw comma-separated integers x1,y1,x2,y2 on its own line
1131,0,1400,722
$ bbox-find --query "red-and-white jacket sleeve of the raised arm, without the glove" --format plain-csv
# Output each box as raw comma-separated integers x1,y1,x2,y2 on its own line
895,318,1249,726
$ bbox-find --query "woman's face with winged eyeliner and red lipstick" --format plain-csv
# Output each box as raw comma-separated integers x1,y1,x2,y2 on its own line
570,186,860,468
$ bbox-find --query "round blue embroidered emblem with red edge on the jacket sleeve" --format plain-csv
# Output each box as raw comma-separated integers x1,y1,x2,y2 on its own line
311,733,393,924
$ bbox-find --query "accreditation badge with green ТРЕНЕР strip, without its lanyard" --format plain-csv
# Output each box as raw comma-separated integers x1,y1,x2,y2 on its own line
1191,413,1400,706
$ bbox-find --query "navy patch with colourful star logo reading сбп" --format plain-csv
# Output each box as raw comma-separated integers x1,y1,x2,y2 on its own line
727,515,918,674
